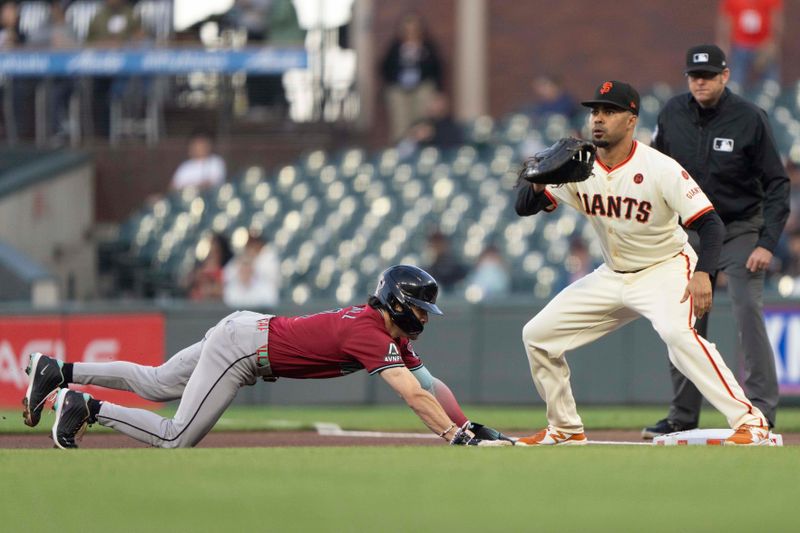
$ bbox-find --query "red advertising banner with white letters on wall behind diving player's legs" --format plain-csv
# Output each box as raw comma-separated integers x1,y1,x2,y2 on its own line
0,313,164,408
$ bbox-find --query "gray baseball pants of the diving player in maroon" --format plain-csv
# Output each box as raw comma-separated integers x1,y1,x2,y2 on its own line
73,311,269,448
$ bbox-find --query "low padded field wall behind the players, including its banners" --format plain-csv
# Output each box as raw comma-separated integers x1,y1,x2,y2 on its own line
0,297,800,408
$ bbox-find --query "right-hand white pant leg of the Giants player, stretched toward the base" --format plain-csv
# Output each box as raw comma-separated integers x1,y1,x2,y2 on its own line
626,252,766,428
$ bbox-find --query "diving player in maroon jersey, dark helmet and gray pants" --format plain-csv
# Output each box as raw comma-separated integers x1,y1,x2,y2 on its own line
23,265,512,448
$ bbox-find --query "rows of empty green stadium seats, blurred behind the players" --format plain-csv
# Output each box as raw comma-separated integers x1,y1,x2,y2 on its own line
108,83,800,304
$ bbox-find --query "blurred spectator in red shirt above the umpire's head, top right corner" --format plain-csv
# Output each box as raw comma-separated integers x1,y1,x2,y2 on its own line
717,0,783,91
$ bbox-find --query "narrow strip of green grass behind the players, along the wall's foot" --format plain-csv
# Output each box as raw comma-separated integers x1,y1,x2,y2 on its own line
0,405,800,433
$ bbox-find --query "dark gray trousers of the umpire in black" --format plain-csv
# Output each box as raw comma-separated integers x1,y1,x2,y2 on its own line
668,218,779,427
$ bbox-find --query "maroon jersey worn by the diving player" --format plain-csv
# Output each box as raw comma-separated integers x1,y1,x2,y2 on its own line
268,305,422,379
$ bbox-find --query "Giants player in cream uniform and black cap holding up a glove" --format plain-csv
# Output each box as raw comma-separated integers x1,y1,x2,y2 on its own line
516,81,769,446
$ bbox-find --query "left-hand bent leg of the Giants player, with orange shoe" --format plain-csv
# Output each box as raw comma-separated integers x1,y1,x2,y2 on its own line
522,266,639,444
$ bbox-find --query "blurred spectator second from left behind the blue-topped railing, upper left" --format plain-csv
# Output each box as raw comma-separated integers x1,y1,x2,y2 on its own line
26,1,79,144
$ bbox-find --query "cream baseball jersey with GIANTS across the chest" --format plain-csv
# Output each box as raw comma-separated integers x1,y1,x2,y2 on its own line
545,141,714,272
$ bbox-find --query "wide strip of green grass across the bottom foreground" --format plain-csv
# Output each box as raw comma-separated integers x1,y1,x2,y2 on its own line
0,446,800,533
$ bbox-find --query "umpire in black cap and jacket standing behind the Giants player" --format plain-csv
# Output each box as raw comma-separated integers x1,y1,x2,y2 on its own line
642,45,789,438
